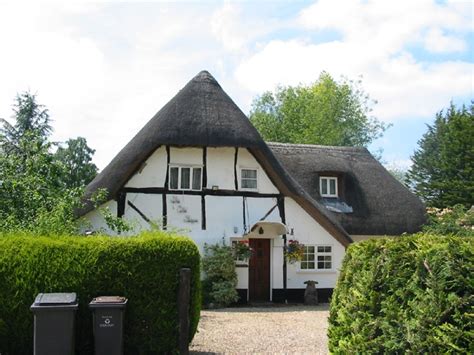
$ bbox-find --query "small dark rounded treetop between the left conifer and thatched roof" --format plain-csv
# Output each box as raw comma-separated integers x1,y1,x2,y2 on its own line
55,137,97,187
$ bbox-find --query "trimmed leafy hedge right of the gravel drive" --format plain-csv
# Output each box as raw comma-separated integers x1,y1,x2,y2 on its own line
328,234,474,354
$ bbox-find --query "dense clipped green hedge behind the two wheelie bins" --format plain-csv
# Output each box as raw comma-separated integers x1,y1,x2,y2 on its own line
0,232,201,354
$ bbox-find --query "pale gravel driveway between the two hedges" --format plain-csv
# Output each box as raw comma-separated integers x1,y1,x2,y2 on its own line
190,305,329,354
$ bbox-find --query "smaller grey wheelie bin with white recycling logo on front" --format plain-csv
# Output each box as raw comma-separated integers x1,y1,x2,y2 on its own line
89,296,128,355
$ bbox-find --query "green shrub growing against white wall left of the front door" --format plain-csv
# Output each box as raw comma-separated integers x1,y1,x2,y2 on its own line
202,244,239,307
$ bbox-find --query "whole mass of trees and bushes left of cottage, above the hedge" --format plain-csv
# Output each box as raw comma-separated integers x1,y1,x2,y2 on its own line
0,92,97,234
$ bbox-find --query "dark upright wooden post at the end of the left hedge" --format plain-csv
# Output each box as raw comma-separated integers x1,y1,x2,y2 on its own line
178,268,191,355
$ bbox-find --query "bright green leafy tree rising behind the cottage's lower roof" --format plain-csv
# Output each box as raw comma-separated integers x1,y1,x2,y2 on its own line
250,72,389,147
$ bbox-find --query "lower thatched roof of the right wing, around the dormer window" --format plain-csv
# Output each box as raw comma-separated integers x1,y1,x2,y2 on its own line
267,143,426,235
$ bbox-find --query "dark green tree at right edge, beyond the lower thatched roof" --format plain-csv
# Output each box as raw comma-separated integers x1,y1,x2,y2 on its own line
407,101,474,208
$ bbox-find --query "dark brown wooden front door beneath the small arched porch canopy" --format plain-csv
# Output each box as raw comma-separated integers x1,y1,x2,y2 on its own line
249,239,270,301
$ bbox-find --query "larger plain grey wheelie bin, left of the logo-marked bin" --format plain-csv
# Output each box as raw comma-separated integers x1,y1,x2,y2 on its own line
30,293,78,355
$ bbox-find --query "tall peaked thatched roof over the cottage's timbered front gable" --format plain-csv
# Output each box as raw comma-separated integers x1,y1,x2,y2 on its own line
78,71,351,245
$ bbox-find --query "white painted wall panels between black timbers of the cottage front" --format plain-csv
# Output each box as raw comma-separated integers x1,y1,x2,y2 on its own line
85,147,345,294
